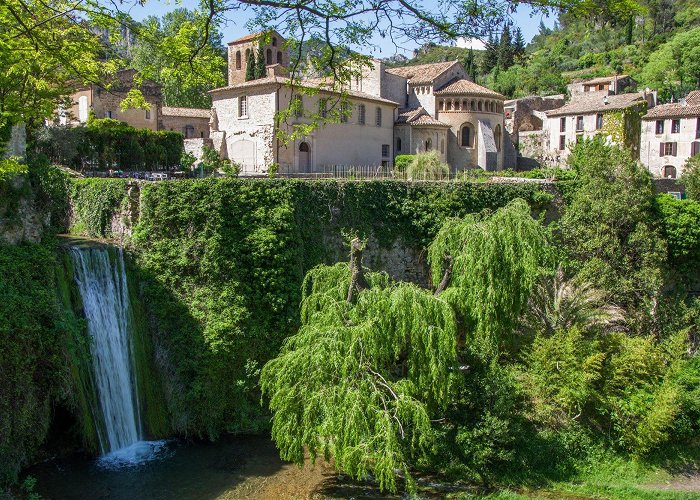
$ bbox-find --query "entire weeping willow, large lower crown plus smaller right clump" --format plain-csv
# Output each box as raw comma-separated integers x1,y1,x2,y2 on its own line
261,201,545,491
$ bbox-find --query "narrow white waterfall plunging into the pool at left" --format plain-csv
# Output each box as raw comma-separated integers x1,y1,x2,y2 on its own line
70,246,165,466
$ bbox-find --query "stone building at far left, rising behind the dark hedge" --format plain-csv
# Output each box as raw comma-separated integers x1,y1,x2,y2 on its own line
57,69,163,130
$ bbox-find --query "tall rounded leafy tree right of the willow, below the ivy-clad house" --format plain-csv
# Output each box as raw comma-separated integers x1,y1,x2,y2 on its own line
560,138,666,328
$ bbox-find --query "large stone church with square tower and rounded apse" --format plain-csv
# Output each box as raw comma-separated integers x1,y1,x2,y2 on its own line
209,32,508,175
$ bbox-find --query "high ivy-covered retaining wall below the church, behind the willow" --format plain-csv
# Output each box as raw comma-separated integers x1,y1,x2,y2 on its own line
72,179,551,437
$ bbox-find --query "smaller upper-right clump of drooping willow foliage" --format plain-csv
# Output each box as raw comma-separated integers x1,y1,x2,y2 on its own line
428,199,549,356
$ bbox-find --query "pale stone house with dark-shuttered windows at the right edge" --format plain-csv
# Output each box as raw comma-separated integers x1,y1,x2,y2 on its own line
641,90,700,179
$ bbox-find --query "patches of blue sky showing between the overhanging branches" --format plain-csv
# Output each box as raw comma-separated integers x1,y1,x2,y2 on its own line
120,0,556,57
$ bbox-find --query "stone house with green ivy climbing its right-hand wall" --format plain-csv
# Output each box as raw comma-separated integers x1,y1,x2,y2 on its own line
545,91,655,164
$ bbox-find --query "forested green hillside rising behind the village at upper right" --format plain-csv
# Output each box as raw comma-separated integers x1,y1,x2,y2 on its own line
387,0,700,101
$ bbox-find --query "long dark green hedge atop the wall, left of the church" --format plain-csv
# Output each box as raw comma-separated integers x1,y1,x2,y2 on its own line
36,118,184,171
